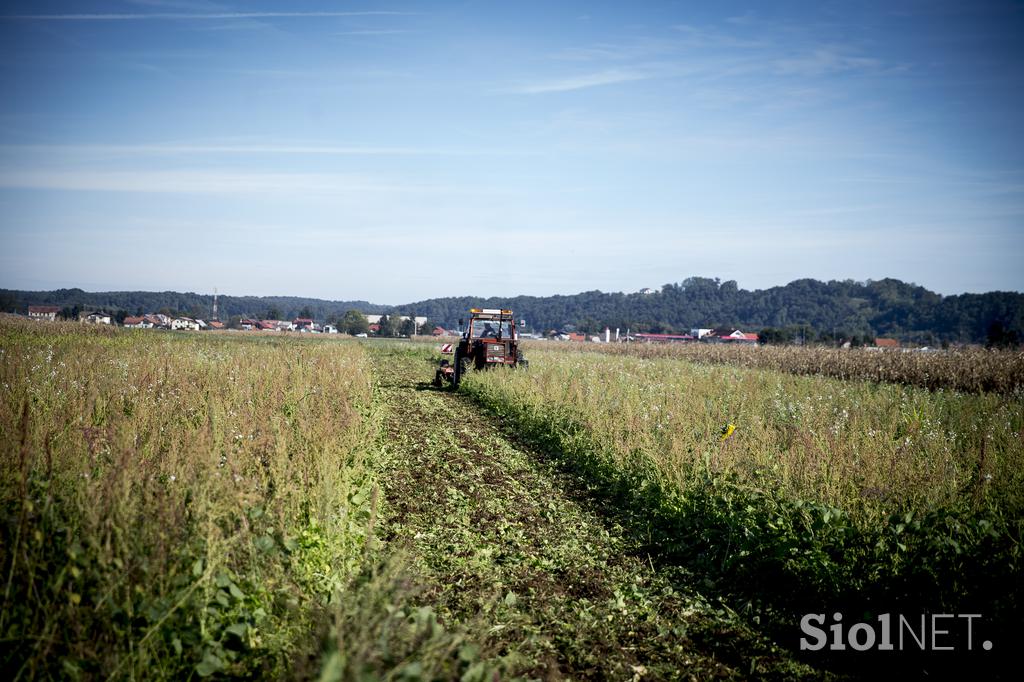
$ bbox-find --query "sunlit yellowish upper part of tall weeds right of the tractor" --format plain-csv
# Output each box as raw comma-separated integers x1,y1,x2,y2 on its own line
479,349,1024,511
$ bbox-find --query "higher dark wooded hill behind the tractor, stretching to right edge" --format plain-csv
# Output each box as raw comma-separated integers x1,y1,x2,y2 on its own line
399,278,1024,343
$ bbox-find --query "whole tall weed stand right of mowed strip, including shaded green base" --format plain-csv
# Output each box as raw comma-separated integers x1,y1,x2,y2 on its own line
461,348,1024,643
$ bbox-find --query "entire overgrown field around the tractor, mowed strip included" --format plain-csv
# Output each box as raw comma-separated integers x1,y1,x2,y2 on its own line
0,319,1024,680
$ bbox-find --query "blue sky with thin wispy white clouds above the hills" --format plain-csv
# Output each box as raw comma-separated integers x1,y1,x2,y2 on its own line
0,0,1024,304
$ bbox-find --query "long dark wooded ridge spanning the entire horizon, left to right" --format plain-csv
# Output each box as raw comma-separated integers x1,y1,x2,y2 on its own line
0,278,1024,343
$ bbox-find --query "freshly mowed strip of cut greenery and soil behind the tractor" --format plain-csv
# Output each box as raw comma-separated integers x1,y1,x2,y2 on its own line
372,347,818,679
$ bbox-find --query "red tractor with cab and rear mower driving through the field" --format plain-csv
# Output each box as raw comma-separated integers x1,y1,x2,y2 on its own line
434,308,527,388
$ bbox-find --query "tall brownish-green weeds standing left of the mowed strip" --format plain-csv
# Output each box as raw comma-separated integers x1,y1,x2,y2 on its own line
0,319,377,679
